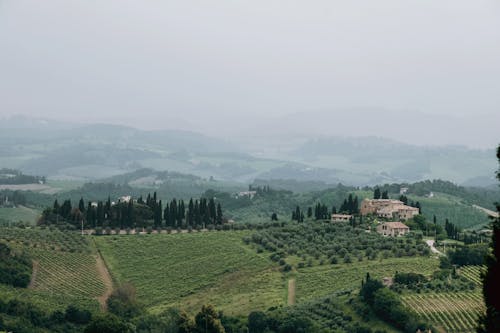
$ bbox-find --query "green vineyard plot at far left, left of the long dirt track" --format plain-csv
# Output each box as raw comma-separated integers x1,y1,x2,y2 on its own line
0,228,105,309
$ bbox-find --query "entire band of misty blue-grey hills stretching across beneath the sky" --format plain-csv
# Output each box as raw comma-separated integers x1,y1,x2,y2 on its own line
0,117,496,186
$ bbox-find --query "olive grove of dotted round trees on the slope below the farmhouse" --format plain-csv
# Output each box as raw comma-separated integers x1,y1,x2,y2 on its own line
245,222,429,267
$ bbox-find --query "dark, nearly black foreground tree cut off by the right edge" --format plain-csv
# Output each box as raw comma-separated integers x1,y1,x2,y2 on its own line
477,145,500,333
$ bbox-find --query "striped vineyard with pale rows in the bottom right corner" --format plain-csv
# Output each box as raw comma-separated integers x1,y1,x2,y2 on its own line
403,292,485,333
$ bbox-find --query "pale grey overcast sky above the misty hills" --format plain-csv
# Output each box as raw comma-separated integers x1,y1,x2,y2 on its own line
0,0,500,145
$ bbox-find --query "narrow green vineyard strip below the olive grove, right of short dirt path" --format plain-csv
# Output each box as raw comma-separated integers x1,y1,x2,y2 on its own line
296,257,439,302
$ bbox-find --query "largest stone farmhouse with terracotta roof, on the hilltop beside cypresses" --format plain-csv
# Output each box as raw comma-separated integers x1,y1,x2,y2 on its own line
360,199,419,221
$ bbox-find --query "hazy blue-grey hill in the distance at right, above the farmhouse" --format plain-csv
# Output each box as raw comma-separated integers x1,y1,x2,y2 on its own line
289,137,495,186
